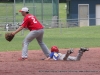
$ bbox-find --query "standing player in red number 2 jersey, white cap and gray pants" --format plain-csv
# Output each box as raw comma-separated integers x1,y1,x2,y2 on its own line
12,7,50,60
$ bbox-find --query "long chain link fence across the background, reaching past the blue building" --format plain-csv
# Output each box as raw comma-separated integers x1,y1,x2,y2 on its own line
0,0,99,30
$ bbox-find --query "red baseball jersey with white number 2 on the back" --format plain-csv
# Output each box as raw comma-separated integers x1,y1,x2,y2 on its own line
22,14,43,31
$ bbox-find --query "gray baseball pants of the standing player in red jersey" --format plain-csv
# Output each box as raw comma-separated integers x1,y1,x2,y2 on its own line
22,29,50,58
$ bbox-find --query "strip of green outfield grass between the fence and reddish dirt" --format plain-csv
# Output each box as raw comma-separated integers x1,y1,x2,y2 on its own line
0,26,100,51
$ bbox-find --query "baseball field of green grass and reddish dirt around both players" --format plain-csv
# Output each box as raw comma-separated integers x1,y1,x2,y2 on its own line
0,2,100,75
